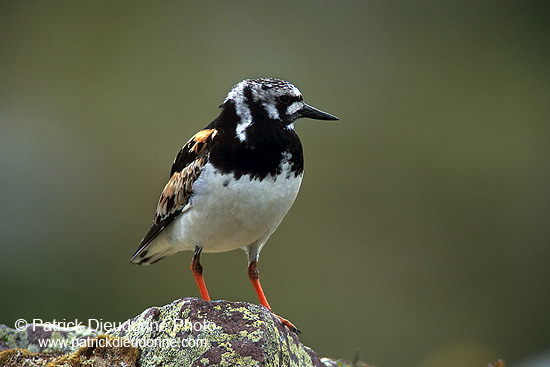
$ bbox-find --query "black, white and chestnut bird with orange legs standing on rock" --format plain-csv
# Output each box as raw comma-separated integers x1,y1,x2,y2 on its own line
130,78,338,333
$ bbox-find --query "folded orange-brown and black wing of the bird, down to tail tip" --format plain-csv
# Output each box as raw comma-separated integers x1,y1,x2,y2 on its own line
130,129,218,264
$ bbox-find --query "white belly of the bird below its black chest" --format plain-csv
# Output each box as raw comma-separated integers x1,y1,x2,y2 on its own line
155,163,302,252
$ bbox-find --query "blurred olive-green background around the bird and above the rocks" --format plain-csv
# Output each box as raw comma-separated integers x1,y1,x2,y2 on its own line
0,1,550,367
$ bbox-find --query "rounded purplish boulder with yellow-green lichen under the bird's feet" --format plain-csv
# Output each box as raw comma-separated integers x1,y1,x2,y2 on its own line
111,298,344,367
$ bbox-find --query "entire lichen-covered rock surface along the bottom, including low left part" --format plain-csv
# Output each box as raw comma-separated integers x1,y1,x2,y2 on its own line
0,298,367,367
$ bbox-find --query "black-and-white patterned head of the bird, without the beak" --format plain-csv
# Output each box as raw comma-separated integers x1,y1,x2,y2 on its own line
224,78,305,142
